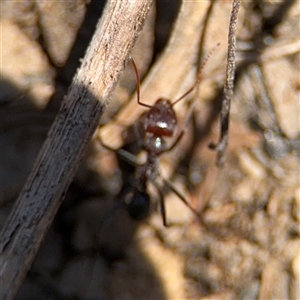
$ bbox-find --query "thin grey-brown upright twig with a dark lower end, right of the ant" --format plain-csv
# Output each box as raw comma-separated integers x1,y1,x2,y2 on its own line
210,0,241,167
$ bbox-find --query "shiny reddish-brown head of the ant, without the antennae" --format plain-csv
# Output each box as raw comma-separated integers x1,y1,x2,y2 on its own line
144,98,177,137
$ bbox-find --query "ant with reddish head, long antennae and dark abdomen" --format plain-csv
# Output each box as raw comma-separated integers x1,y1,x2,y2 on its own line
101,44,219,227
